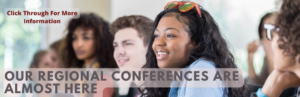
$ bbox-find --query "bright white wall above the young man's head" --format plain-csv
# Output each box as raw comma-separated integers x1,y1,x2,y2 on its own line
110,0,202,22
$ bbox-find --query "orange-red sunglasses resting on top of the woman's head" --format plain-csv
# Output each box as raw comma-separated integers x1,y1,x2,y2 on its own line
164,1,202,17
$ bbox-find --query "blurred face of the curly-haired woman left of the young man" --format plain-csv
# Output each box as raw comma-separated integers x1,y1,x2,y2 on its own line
72,27,96,60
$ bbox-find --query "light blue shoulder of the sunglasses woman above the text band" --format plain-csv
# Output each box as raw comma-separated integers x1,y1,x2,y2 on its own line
186,58,216,68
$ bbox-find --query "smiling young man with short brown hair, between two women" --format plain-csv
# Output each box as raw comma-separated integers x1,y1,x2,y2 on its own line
110,15,153,97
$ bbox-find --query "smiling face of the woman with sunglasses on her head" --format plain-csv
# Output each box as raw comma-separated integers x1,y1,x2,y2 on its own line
152,16,194,68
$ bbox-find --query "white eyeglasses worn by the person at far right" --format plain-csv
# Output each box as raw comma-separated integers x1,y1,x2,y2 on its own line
264,24,279,40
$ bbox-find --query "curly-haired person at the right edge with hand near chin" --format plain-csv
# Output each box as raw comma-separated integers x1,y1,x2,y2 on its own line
256,0,300,97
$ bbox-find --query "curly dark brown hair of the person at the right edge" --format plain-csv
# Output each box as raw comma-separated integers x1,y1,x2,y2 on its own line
276,0,300,62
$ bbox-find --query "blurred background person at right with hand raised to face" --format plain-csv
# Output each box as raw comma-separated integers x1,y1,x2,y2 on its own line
247,12,278,85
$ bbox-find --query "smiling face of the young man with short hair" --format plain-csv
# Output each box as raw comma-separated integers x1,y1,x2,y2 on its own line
113,28,147,68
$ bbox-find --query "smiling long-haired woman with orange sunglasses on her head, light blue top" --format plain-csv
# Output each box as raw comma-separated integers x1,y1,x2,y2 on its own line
142,1,243,97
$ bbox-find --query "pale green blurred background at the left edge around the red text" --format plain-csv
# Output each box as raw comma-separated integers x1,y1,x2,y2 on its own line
0,0,42,69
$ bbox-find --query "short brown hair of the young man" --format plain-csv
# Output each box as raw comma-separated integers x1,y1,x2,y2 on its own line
110,15,153,46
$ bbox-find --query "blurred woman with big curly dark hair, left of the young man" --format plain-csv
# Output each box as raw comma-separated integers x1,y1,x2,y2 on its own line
60,13,118,97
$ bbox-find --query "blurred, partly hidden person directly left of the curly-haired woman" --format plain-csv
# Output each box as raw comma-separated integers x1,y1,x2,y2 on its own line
50,39,63,68
